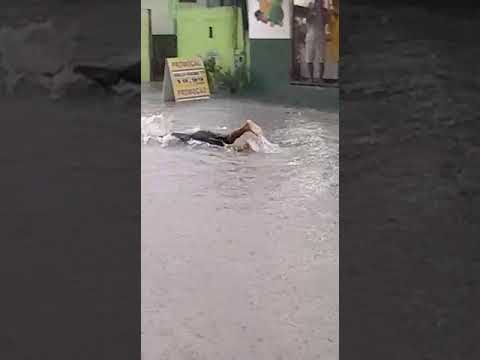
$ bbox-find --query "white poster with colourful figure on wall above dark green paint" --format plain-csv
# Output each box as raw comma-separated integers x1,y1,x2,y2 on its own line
248,0,291,39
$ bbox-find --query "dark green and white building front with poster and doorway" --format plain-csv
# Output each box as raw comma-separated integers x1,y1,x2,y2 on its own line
248,0,339,109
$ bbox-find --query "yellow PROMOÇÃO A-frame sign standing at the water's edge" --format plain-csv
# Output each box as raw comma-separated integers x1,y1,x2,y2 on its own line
163,58,210,102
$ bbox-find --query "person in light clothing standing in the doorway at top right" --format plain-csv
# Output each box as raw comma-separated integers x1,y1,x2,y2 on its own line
305,0,328,82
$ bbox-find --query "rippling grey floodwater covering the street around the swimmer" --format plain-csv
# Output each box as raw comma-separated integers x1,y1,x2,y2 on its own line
142,85,338,360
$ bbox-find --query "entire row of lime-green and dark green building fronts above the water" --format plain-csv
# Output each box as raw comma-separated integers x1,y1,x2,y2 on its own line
142,0,339,108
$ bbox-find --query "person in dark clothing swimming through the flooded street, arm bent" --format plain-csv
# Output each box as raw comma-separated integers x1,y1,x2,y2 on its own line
171,120,263,150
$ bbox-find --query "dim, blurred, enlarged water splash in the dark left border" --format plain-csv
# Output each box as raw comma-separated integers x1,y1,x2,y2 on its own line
0,20,140,99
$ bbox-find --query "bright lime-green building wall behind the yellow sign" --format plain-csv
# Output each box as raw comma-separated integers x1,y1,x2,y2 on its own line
142,0,249,82
